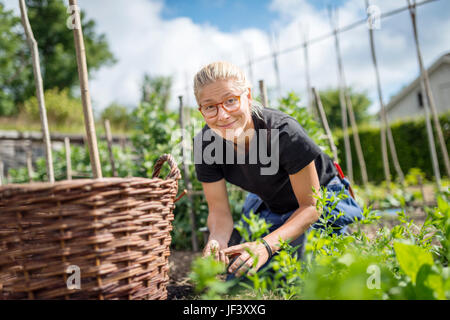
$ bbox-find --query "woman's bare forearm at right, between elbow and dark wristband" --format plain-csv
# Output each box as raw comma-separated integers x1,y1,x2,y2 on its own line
264,206,319,252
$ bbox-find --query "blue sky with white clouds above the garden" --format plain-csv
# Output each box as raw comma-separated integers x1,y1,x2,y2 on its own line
6,0,450,113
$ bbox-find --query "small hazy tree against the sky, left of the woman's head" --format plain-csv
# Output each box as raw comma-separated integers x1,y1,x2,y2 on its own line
142,74,172,111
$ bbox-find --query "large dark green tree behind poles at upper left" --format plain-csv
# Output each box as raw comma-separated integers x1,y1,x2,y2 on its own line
0,0,116,113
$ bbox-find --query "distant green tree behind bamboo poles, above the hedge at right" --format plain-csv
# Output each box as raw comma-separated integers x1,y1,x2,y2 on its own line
319,88,372,130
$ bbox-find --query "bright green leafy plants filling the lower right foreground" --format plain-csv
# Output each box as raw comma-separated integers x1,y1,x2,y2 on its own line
187,182,450,300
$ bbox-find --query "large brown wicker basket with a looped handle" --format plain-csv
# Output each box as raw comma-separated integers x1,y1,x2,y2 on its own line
0,155,180,299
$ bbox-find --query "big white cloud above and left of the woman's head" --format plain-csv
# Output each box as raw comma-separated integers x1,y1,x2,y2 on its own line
73,0,267,112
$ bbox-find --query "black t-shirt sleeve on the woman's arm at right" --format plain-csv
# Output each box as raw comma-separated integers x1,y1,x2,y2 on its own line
279,118,322,174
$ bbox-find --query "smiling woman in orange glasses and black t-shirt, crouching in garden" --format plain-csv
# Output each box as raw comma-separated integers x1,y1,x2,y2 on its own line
194,62,362,275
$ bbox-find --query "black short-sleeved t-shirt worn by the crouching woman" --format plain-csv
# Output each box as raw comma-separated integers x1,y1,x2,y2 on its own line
194,108,337,214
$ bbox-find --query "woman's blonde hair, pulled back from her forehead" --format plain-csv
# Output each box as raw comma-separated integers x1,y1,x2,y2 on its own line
194,61,263,119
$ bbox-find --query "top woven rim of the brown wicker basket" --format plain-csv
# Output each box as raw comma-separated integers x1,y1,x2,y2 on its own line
0,177,176,193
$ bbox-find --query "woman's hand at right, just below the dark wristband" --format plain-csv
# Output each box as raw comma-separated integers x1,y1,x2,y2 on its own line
220,241,269,276
